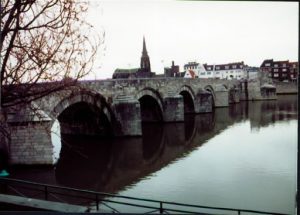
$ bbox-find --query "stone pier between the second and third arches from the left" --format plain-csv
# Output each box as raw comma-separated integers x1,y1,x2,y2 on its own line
163,95,184,122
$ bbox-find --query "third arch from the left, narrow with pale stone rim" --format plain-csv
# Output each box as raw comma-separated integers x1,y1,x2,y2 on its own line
178,85,195,113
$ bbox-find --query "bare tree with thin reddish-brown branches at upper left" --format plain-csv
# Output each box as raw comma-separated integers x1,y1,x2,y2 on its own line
0,0,104,160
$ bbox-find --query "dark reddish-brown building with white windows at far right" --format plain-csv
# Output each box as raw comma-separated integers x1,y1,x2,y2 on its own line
260,59,298,82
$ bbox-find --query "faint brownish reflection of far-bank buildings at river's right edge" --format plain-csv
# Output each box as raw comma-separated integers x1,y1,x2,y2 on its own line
249,95,298,131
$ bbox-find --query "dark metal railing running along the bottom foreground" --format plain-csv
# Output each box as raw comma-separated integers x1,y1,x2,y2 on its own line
0,177,290,215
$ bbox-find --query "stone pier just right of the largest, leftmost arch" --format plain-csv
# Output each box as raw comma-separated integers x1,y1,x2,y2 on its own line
112,95,142,136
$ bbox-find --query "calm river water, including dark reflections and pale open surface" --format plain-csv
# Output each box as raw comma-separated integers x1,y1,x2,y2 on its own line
7,96,298,214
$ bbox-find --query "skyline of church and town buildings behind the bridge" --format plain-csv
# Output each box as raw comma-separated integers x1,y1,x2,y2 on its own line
113,38,298,82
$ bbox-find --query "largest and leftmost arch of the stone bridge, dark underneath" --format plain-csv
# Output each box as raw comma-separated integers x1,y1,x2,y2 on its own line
51,91,113,136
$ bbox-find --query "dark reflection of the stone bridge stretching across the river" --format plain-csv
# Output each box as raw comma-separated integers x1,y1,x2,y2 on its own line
56,95,297,192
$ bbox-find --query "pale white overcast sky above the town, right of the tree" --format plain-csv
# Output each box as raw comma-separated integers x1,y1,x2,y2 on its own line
87,0,299,79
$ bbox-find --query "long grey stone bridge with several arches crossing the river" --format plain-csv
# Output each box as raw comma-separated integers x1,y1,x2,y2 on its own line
8,78,274,164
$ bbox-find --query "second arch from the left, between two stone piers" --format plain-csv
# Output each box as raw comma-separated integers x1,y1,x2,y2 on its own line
136,88,164,122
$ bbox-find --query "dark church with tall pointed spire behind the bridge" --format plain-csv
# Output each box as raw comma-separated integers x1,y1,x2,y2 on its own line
112,37,155,79
